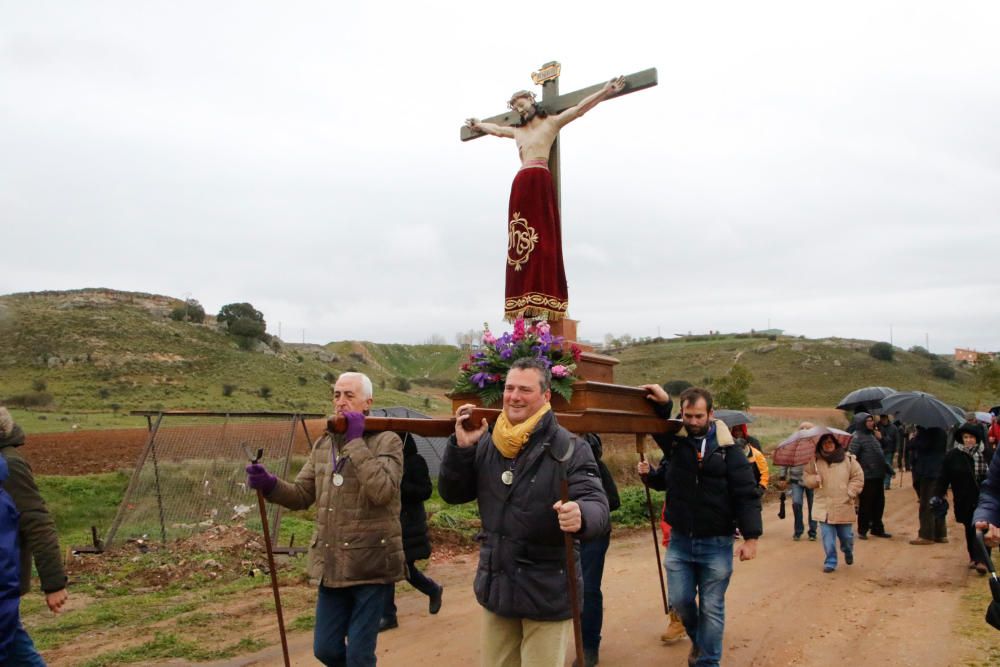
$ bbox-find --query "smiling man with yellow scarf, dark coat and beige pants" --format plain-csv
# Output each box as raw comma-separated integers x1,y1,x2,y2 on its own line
438,358,610,667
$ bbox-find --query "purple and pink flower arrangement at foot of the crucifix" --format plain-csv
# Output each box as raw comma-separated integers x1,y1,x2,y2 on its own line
452,318,581,406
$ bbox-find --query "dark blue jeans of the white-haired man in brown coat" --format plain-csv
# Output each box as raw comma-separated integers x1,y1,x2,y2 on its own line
313,584,385,667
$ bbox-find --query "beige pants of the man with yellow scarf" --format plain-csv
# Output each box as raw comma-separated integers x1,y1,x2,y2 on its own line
479,609,573,667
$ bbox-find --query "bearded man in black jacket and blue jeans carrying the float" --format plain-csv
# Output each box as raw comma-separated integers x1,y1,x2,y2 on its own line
642,384,763,667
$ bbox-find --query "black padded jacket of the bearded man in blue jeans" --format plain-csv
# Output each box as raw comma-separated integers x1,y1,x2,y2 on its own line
649,418,764,539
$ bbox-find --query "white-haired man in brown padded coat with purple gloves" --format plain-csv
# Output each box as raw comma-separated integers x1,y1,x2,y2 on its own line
247,373,404,667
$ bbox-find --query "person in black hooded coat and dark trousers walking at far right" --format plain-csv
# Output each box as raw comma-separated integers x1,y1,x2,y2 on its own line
932,424,991,574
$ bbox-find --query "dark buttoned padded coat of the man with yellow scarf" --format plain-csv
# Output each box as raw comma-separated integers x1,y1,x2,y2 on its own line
438,412,610,621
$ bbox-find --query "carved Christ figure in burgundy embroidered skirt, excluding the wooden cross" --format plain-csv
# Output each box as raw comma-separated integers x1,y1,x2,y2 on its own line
465,77,625,321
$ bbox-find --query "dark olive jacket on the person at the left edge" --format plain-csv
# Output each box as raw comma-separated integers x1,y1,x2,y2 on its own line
0,424,66,595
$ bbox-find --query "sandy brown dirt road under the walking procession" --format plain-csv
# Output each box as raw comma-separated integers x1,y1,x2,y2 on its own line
211,472,985,667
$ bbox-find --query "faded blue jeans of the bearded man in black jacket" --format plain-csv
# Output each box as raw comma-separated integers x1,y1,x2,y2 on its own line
665,533,733,667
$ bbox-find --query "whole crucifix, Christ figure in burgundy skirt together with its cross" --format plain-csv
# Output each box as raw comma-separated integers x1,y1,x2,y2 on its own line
461,62,656,321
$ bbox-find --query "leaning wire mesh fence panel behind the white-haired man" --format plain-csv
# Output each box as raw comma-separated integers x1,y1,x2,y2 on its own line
104,412,317,548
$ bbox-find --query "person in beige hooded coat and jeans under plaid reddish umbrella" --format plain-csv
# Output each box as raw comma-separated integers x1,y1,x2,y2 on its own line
802,432,865,574
